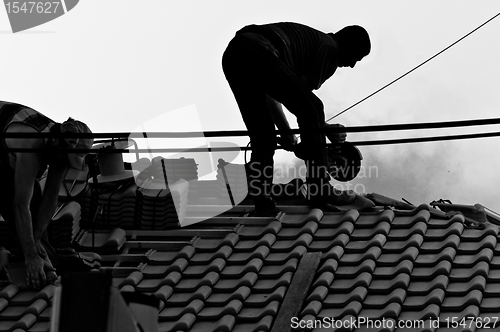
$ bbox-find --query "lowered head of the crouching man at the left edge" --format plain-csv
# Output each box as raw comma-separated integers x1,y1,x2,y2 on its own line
61,118,94,170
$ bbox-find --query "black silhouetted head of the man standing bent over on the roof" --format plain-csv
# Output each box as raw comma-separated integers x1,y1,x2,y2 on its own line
335,25,371,68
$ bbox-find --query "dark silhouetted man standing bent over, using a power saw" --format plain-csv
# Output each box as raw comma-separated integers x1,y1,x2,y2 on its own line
222,22,371,216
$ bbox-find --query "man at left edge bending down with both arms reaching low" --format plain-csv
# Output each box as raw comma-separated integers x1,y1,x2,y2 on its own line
0,101,93,288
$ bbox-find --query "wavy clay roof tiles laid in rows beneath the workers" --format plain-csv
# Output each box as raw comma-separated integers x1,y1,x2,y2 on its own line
0,192,500,332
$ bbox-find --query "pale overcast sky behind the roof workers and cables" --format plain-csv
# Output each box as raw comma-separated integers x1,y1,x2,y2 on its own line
0,0,500,211
